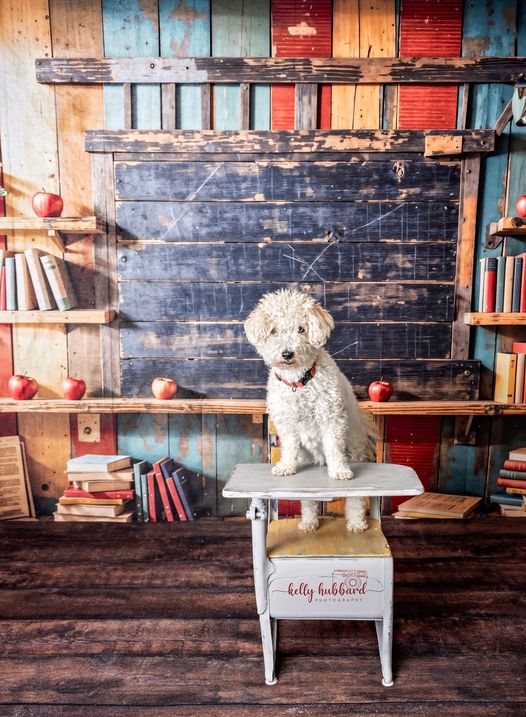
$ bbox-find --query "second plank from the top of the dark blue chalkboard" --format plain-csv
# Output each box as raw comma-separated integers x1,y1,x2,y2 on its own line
116,201,458,243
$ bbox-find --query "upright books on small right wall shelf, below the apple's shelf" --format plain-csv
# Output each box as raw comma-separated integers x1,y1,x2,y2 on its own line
478,254,526,313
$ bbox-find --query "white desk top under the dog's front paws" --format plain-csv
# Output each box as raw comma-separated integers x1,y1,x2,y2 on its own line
223,463,424,500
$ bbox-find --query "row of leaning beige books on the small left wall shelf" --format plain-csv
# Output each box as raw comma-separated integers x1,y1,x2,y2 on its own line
0,248,77,311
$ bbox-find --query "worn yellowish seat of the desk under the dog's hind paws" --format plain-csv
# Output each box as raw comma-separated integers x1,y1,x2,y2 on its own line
267,518,391,560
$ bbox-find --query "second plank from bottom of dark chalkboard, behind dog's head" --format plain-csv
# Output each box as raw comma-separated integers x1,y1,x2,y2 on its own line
120,320,450,359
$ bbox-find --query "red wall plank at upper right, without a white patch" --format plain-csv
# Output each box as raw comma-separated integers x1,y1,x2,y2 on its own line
398,0,462,129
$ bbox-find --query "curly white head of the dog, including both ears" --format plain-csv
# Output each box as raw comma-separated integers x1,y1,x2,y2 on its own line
245,289,334,369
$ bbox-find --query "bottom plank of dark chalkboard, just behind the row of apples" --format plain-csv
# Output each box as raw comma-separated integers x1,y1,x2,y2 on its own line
121,358,479,400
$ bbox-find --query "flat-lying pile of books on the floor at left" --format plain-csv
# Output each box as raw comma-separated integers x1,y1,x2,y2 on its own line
53,454,135,523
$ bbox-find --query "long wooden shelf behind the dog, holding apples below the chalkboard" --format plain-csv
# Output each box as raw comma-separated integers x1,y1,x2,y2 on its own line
0,398,526,416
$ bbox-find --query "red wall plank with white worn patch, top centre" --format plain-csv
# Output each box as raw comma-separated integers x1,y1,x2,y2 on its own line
271,0,332,129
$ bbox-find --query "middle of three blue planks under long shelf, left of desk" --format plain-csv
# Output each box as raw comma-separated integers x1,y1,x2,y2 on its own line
168,414,217,515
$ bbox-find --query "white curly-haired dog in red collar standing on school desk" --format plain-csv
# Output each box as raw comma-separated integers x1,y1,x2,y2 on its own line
245,289,375,533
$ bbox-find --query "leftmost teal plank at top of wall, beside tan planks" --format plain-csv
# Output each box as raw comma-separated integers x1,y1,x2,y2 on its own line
102,0,161,129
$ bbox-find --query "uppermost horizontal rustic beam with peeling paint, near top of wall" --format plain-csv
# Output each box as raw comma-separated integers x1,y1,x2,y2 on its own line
35,57,526,85
